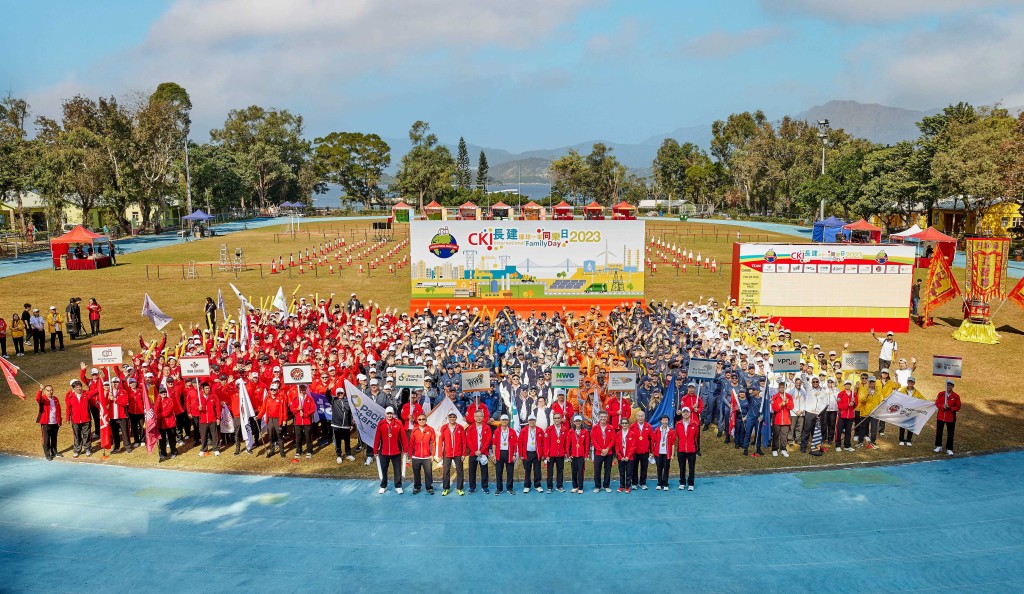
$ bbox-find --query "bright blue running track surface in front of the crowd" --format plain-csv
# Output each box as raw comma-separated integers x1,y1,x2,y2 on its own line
0,452,1024,592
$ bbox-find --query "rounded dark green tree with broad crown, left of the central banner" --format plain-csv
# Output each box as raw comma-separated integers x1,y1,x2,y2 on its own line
313,132,391,205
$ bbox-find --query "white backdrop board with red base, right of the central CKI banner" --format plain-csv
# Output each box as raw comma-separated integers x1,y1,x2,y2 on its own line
731,243,915,332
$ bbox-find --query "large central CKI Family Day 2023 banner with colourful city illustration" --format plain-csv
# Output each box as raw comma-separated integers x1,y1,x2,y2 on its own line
410,220,644,306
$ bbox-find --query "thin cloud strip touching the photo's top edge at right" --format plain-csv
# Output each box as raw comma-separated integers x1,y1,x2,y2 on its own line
761,0,1021,24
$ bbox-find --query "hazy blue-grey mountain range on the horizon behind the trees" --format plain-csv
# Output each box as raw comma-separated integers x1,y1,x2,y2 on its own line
384,100,987,183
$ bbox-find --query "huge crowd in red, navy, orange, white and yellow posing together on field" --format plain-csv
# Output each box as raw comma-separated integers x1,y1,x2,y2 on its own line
27,294,961,495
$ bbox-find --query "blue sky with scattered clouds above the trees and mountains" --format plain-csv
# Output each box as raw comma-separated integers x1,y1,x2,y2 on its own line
0,0,1024,152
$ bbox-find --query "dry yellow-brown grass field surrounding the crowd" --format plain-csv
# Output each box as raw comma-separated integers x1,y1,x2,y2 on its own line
0,221,1024,477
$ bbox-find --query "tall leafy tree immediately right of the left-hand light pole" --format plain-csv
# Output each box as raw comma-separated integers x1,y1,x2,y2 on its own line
210,105,309,210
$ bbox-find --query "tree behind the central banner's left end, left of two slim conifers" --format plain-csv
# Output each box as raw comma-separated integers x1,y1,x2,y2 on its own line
395,121,456,210
